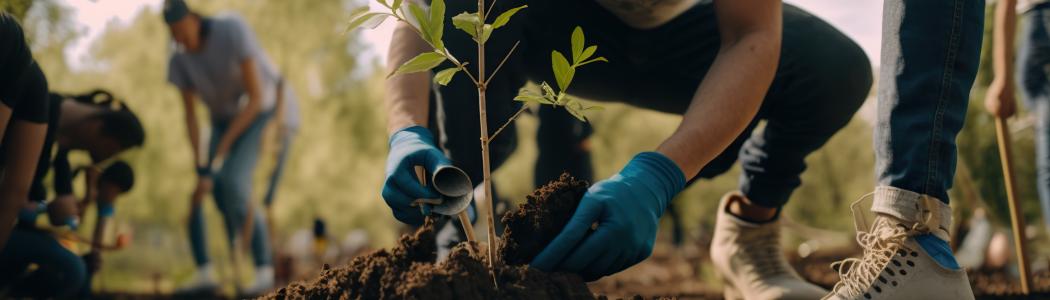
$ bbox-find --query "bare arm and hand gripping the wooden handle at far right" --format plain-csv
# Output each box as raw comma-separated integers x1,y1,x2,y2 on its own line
985,0,1017,117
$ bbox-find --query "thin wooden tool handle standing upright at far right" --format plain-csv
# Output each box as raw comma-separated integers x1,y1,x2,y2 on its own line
995,117,1032,295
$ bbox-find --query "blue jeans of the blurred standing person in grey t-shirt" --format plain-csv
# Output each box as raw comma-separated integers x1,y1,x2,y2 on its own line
189,111,273,266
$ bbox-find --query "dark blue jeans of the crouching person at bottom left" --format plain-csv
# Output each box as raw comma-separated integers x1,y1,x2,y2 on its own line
0,227,90,299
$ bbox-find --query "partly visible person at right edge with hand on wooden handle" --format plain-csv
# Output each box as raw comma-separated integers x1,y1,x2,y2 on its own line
985,0,1050,233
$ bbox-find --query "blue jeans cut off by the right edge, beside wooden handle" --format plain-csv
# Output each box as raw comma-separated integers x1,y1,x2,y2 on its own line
1016,4,1050,228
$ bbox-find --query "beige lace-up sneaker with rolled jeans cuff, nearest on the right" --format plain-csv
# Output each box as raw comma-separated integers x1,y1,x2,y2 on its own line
824,187,973,300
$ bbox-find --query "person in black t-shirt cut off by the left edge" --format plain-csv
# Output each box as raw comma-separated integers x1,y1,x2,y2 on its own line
0,10,48,249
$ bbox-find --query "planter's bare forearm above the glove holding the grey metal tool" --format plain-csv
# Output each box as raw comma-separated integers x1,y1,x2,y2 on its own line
383,23,431,134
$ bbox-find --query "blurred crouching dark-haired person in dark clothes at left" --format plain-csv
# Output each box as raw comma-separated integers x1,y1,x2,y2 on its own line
0,86,145,298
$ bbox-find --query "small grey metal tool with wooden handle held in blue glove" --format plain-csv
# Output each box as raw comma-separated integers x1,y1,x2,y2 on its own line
413,166,475,241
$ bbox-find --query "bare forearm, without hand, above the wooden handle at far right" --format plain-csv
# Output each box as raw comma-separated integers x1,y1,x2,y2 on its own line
992,0,1017,83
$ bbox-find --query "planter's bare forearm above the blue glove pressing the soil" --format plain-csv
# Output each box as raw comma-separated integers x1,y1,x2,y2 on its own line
657,30,780,178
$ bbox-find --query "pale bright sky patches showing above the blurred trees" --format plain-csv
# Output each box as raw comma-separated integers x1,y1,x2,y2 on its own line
55,0,882,68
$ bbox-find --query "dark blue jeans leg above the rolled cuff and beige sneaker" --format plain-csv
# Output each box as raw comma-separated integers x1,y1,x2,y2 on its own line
875,0,985,203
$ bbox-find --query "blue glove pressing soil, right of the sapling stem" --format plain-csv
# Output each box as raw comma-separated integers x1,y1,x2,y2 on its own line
531,152,686,281
